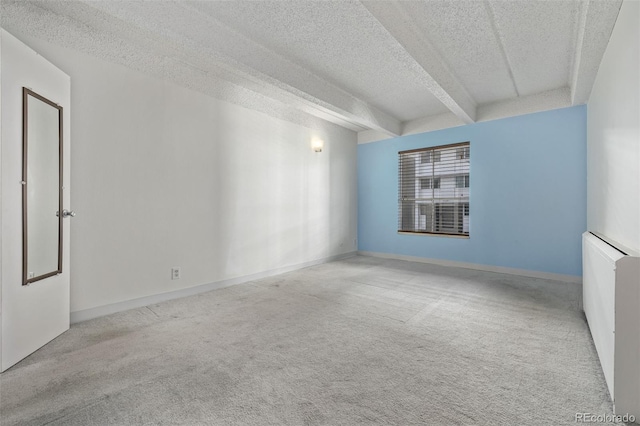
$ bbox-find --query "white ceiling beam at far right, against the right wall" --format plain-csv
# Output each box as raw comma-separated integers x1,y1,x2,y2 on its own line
569,0,622,105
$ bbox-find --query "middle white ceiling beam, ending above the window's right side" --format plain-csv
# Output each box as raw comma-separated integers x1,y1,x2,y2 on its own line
361,0,477,123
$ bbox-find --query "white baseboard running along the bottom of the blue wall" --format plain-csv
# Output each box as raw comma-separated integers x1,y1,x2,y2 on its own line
358,251,582,284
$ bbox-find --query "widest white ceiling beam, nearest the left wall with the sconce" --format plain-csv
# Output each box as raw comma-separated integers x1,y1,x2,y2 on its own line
76,0,402,136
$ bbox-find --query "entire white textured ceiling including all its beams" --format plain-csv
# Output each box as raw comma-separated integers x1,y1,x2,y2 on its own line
2,0,621,141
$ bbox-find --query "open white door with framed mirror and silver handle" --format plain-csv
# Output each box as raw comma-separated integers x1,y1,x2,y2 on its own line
0,30,71,371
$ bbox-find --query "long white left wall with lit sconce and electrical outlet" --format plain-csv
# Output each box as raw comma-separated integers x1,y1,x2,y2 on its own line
10,38,357,312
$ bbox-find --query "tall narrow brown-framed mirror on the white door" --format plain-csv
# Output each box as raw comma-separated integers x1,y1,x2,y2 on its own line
22,87,63,285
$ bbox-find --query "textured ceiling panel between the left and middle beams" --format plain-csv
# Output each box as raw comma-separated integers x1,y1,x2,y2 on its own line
194,1,446,121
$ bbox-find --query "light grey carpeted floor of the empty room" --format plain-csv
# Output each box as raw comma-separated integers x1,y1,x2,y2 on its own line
0,256,612,426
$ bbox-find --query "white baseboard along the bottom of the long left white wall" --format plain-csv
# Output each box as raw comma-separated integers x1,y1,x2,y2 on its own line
71,251,357,324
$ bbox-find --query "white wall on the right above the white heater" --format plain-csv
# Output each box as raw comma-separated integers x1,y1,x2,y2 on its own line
587,0,640,251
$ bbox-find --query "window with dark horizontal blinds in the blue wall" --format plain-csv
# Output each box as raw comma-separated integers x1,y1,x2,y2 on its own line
398,142,470,236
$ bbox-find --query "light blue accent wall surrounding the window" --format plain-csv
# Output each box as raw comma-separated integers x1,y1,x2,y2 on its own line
358,106,587,276
